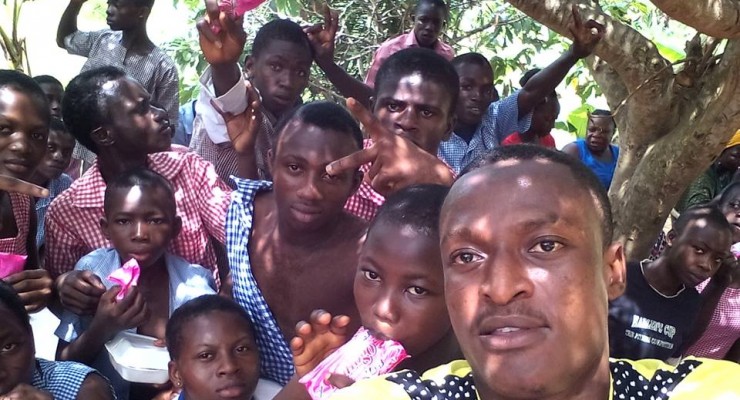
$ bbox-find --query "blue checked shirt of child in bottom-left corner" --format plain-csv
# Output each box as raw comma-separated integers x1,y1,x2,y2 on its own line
31,358,112,400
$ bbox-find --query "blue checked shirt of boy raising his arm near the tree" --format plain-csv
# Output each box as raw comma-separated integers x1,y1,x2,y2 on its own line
437,91,532,174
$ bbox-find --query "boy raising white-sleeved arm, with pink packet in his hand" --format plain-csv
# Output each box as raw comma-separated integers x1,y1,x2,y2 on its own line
190,13,313,187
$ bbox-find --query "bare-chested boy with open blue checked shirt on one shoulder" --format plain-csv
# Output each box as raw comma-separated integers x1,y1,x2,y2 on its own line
226,102,366,385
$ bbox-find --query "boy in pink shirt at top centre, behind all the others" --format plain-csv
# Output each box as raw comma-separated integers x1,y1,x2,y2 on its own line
365,0,455,88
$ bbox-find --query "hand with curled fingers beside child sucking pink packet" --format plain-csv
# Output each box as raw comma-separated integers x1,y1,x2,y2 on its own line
290,310,350,378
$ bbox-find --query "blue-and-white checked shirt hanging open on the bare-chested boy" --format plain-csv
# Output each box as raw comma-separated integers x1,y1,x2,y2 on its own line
226,177,295,385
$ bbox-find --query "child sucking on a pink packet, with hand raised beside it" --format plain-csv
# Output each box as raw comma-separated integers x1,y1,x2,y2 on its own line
284,185,462,398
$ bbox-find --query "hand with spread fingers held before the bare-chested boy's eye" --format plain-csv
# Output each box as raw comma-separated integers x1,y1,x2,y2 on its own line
326,98,454,196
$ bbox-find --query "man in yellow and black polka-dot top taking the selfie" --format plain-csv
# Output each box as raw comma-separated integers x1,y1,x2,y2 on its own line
332,145,740,400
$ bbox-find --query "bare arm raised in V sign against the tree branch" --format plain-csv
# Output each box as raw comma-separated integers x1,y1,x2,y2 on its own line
517,6,604,118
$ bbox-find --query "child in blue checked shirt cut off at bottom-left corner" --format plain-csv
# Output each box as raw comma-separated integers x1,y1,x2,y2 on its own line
0,281,114,400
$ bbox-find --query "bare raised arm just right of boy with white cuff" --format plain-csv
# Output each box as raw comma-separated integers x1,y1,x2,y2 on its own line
305,5,373,107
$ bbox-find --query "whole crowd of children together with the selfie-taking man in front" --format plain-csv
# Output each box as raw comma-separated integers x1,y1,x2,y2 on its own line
0,0,740,400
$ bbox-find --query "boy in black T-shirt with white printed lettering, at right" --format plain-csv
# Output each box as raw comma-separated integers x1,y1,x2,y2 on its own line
609,206,732,360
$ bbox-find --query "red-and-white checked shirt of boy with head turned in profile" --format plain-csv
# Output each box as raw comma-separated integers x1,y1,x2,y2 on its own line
45,152,231,277
